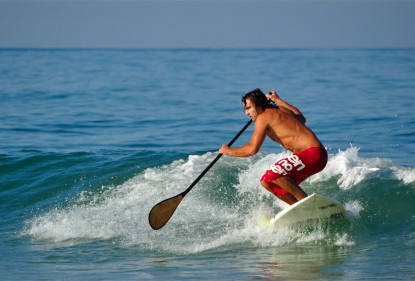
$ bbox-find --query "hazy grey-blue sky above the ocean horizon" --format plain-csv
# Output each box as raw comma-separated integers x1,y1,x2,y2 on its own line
0,0,415,48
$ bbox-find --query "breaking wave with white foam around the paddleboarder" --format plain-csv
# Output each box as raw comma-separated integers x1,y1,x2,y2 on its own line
21,147,415,253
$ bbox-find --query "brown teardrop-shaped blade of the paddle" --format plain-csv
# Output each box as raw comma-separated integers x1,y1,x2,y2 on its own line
148,194,184,230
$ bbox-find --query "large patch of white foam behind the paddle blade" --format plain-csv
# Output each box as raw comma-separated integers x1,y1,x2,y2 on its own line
23,153,247,252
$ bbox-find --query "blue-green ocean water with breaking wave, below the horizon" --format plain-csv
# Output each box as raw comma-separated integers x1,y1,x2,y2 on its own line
0,49,415,280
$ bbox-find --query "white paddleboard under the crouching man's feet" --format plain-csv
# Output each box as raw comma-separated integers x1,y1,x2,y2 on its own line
269,193,346,227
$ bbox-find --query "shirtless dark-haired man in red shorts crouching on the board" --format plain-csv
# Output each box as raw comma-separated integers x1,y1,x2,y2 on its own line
219,89,327,205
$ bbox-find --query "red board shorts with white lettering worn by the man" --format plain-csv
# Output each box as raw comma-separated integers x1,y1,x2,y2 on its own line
261,147,328,195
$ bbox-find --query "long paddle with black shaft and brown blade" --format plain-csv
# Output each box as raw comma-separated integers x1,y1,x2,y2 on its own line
148,120,252,230
